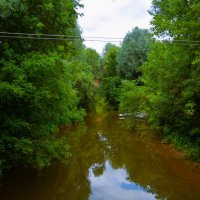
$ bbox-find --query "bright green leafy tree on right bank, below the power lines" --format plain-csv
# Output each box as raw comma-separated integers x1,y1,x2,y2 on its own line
143,42,200,157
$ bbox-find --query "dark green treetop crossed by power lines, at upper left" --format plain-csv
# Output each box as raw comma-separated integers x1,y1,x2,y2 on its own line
0,0,82,55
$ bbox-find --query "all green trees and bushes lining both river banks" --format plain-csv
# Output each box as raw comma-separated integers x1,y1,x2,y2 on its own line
0,0,200,175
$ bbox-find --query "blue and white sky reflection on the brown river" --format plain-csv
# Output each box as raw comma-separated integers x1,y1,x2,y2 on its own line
89,161,155,200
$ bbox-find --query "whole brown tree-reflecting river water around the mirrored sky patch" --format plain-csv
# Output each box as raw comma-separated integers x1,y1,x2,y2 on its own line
0,114,200,200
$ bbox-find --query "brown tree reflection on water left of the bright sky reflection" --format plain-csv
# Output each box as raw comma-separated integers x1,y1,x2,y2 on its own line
0,120,105,200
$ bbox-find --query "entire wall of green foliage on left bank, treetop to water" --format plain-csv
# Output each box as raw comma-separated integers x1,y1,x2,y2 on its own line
0,0,98,171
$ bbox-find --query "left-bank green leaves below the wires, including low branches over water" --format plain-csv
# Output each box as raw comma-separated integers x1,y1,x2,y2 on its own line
0,50,84,171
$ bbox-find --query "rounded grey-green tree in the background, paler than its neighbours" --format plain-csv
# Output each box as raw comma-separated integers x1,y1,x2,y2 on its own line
118,27,149,80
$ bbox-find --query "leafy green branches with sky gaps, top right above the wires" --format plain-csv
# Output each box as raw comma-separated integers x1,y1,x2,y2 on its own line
150,0,200,40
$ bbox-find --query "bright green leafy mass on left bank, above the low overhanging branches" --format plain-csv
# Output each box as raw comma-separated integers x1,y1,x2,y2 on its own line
0,53,83,136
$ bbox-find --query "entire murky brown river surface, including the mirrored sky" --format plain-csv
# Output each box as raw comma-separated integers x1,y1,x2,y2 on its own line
0,113,200,200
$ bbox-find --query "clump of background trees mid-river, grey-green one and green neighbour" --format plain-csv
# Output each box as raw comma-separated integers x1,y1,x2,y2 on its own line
101,27,150,112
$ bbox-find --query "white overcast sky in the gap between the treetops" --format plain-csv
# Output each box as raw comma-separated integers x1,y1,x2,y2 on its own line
79,0,151,53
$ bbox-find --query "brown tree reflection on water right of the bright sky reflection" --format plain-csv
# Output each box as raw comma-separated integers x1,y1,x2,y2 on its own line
103,112,200,200
